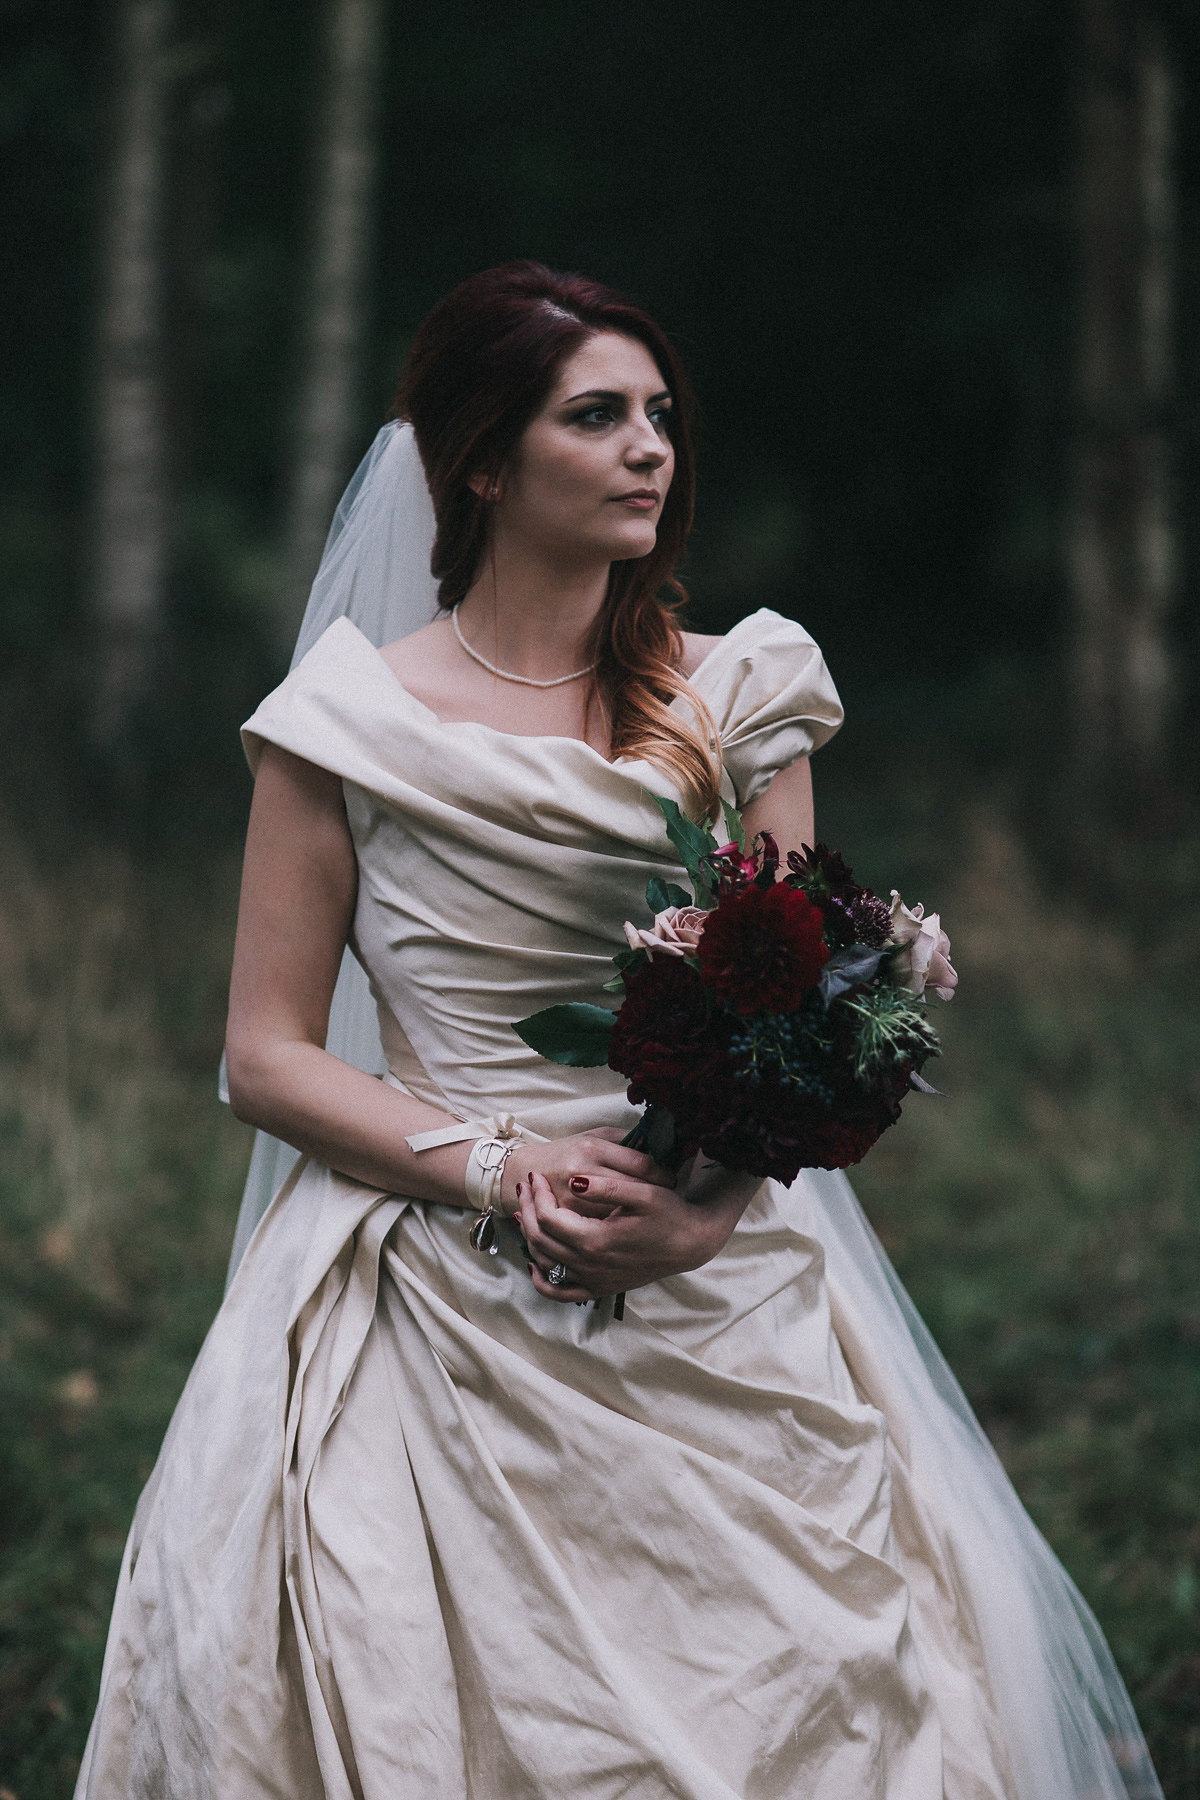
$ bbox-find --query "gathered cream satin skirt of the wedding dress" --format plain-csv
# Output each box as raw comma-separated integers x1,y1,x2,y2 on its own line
77,1161,1150,1800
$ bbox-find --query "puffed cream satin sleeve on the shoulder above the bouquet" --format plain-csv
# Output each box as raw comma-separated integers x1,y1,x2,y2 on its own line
691,607,842,806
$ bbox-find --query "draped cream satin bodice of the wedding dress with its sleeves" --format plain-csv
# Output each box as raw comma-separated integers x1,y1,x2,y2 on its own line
243,610,842,1138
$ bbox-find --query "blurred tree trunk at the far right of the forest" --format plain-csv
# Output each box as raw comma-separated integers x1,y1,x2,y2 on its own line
1069,0,1178,810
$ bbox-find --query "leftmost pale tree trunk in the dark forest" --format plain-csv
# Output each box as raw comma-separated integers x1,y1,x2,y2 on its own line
92,0,171,747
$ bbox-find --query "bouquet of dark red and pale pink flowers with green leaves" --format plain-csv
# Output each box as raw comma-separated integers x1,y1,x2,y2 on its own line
516,796,957,1183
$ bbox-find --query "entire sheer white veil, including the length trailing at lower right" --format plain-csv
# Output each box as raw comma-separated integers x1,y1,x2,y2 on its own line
218,425,1162,1800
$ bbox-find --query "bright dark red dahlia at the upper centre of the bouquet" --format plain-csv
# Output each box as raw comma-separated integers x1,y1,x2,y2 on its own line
696,882,829,1013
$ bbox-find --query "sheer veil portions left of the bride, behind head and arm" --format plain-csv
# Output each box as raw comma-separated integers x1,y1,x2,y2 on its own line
221,425,437,1285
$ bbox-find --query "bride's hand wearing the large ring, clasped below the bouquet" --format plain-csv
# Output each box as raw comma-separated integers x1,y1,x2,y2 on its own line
509,1134,759,1300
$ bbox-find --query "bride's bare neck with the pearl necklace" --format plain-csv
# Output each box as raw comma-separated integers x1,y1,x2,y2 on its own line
459,545,610,680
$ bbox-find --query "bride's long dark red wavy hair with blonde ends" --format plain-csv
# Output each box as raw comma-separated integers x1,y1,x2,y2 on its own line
394,261,720,817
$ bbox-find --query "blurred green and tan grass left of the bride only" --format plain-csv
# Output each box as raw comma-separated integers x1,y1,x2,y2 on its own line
0,821,250,1800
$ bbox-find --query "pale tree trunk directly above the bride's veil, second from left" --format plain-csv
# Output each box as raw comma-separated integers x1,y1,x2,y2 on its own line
279,0,383,652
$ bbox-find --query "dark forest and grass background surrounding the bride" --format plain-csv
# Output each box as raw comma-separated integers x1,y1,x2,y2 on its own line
0,0,1200,1800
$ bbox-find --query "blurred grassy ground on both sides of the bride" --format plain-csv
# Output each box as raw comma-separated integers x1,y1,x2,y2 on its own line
0,763,1200,1800
